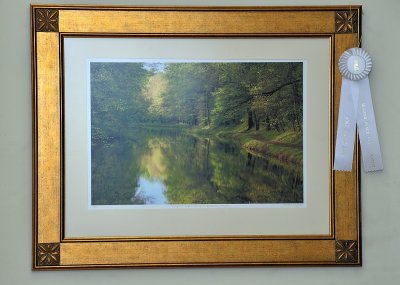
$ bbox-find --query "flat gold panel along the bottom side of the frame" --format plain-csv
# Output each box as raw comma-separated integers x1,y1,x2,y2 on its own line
61,240,335,266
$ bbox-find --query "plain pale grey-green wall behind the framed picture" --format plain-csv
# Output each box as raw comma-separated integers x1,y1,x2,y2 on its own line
0,0,400,285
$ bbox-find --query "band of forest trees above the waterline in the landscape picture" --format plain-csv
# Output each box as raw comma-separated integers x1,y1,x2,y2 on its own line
90,62,303,140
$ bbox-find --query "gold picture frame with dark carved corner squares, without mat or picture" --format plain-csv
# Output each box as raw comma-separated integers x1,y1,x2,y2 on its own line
31,5,362,270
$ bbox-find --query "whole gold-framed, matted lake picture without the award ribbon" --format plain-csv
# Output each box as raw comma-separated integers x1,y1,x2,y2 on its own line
31,5,361,270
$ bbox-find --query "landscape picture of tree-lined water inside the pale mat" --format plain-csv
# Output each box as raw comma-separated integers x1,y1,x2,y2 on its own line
89,60,304,206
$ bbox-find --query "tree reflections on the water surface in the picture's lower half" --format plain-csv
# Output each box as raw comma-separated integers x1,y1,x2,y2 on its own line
92,129,303,205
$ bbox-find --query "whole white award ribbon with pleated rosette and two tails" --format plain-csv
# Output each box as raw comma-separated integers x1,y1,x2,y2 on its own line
334,48,383,172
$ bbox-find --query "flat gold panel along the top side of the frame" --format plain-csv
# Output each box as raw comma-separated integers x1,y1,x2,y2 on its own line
60,10,335,34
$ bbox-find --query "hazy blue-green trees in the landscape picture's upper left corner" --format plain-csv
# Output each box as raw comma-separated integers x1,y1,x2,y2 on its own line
90,62,151,144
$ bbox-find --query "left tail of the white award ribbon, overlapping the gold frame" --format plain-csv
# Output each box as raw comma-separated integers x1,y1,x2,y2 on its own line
333,78,359,171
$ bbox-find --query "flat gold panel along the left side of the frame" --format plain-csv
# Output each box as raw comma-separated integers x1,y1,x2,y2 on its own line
35,33,61,243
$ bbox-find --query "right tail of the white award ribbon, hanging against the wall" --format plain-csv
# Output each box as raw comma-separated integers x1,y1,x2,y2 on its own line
357,77,383,172
